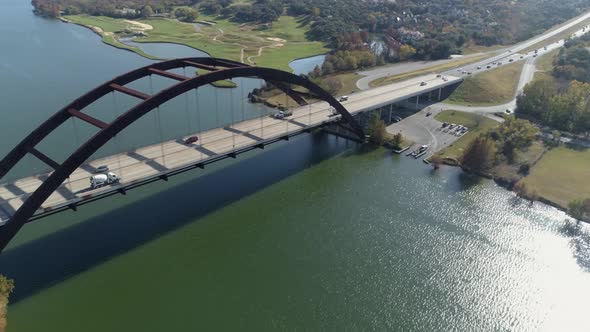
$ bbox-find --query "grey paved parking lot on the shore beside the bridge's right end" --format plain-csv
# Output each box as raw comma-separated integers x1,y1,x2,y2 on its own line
387,107,468,158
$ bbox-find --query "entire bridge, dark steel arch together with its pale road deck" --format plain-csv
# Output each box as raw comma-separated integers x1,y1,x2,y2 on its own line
0,58,462,250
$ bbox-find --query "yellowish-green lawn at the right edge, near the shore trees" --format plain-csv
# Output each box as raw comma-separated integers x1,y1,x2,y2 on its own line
524,147,590,207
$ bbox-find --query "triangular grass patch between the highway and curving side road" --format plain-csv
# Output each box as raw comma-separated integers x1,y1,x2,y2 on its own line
445,61,524,106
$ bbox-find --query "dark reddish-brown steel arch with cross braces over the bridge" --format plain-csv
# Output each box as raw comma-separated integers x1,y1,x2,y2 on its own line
0,58,365,251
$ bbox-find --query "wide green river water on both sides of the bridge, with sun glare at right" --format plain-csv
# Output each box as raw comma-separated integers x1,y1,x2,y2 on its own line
0,0,590,332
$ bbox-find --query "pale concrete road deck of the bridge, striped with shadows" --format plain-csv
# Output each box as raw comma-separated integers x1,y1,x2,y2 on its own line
0,75,462,223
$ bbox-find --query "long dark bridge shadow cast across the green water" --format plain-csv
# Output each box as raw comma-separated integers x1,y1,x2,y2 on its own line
0,133,357,303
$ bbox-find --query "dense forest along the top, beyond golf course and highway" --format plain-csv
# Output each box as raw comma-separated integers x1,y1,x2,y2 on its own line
32,0,590,62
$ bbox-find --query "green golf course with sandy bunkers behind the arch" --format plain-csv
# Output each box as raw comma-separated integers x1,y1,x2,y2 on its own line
66,14,329,71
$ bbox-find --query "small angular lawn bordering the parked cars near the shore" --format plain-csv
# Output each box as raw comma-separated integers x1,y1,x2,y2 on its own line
434,110,500,160
